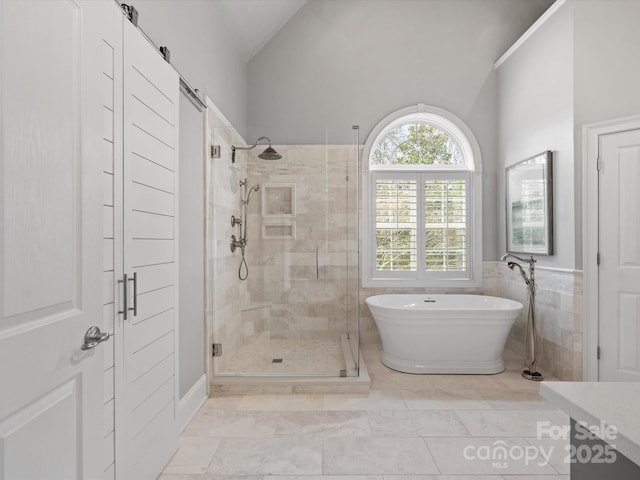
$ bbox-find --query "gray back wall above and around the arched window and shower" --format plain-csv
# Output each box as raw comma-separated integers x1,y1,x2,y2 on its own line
248,0,552,260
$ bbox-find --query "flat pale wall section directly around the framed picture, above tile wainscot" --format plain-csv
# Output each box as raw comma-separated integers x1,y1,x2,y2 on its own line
497,3,576,269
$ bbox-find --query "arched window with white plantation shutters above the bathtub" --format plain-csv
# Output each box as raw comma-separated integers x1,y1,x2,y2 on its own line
363,104,482,287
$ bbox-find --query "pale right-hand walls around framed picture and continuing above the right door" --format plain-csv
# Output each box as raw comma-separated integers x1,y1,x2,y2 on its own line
498,0,640,270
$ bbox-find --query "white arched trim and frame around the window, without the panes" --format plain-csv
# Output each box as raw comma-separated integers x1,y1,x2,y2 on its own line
361,104,482,288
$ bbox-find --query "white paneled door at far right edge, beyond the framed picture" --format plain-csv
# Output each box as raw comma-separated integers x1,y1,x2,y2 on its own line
598,130,640,381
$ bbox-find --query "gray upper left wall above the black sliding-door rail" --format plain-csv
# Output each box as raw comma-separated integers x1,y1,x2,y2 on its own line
133,0,247,134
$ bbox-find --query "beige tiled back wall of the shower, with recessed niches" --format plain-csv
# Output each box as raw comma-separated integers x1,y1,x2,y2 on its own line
245,145,358,340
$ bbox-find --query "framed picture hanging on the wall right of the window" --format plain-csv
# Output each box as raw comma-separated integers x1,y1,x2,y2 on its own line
505,150,553,255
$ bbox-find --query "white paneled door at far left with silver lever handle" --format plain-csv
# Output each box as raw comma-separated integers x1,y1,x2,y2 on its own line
0,0,103,480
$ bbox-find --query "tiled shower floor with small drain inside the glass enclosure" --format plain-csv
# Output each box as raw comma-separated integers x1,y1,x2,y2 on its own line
220,332,345,377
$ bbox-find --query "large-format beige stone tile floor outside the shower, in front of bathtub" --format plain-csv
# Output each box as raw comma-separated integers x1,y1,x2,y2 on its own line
159,345,569,480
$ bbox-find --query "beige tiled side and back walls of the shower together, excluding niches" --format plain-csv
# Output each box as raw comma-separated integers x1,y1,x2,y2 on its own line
207,141,358,375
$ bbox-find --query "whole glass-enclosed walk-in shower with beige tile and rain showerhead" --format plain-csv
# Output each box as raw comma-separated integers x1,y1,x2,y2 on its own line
208,126,360,384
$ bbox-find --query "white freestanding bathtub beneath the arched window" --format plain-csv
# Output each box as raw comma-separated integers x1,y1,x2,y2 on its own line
366,294,522,374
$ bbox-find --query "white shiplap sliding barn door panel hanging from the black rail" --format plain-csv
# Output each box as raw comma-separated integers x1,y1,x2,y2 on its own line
122,16,179,479
